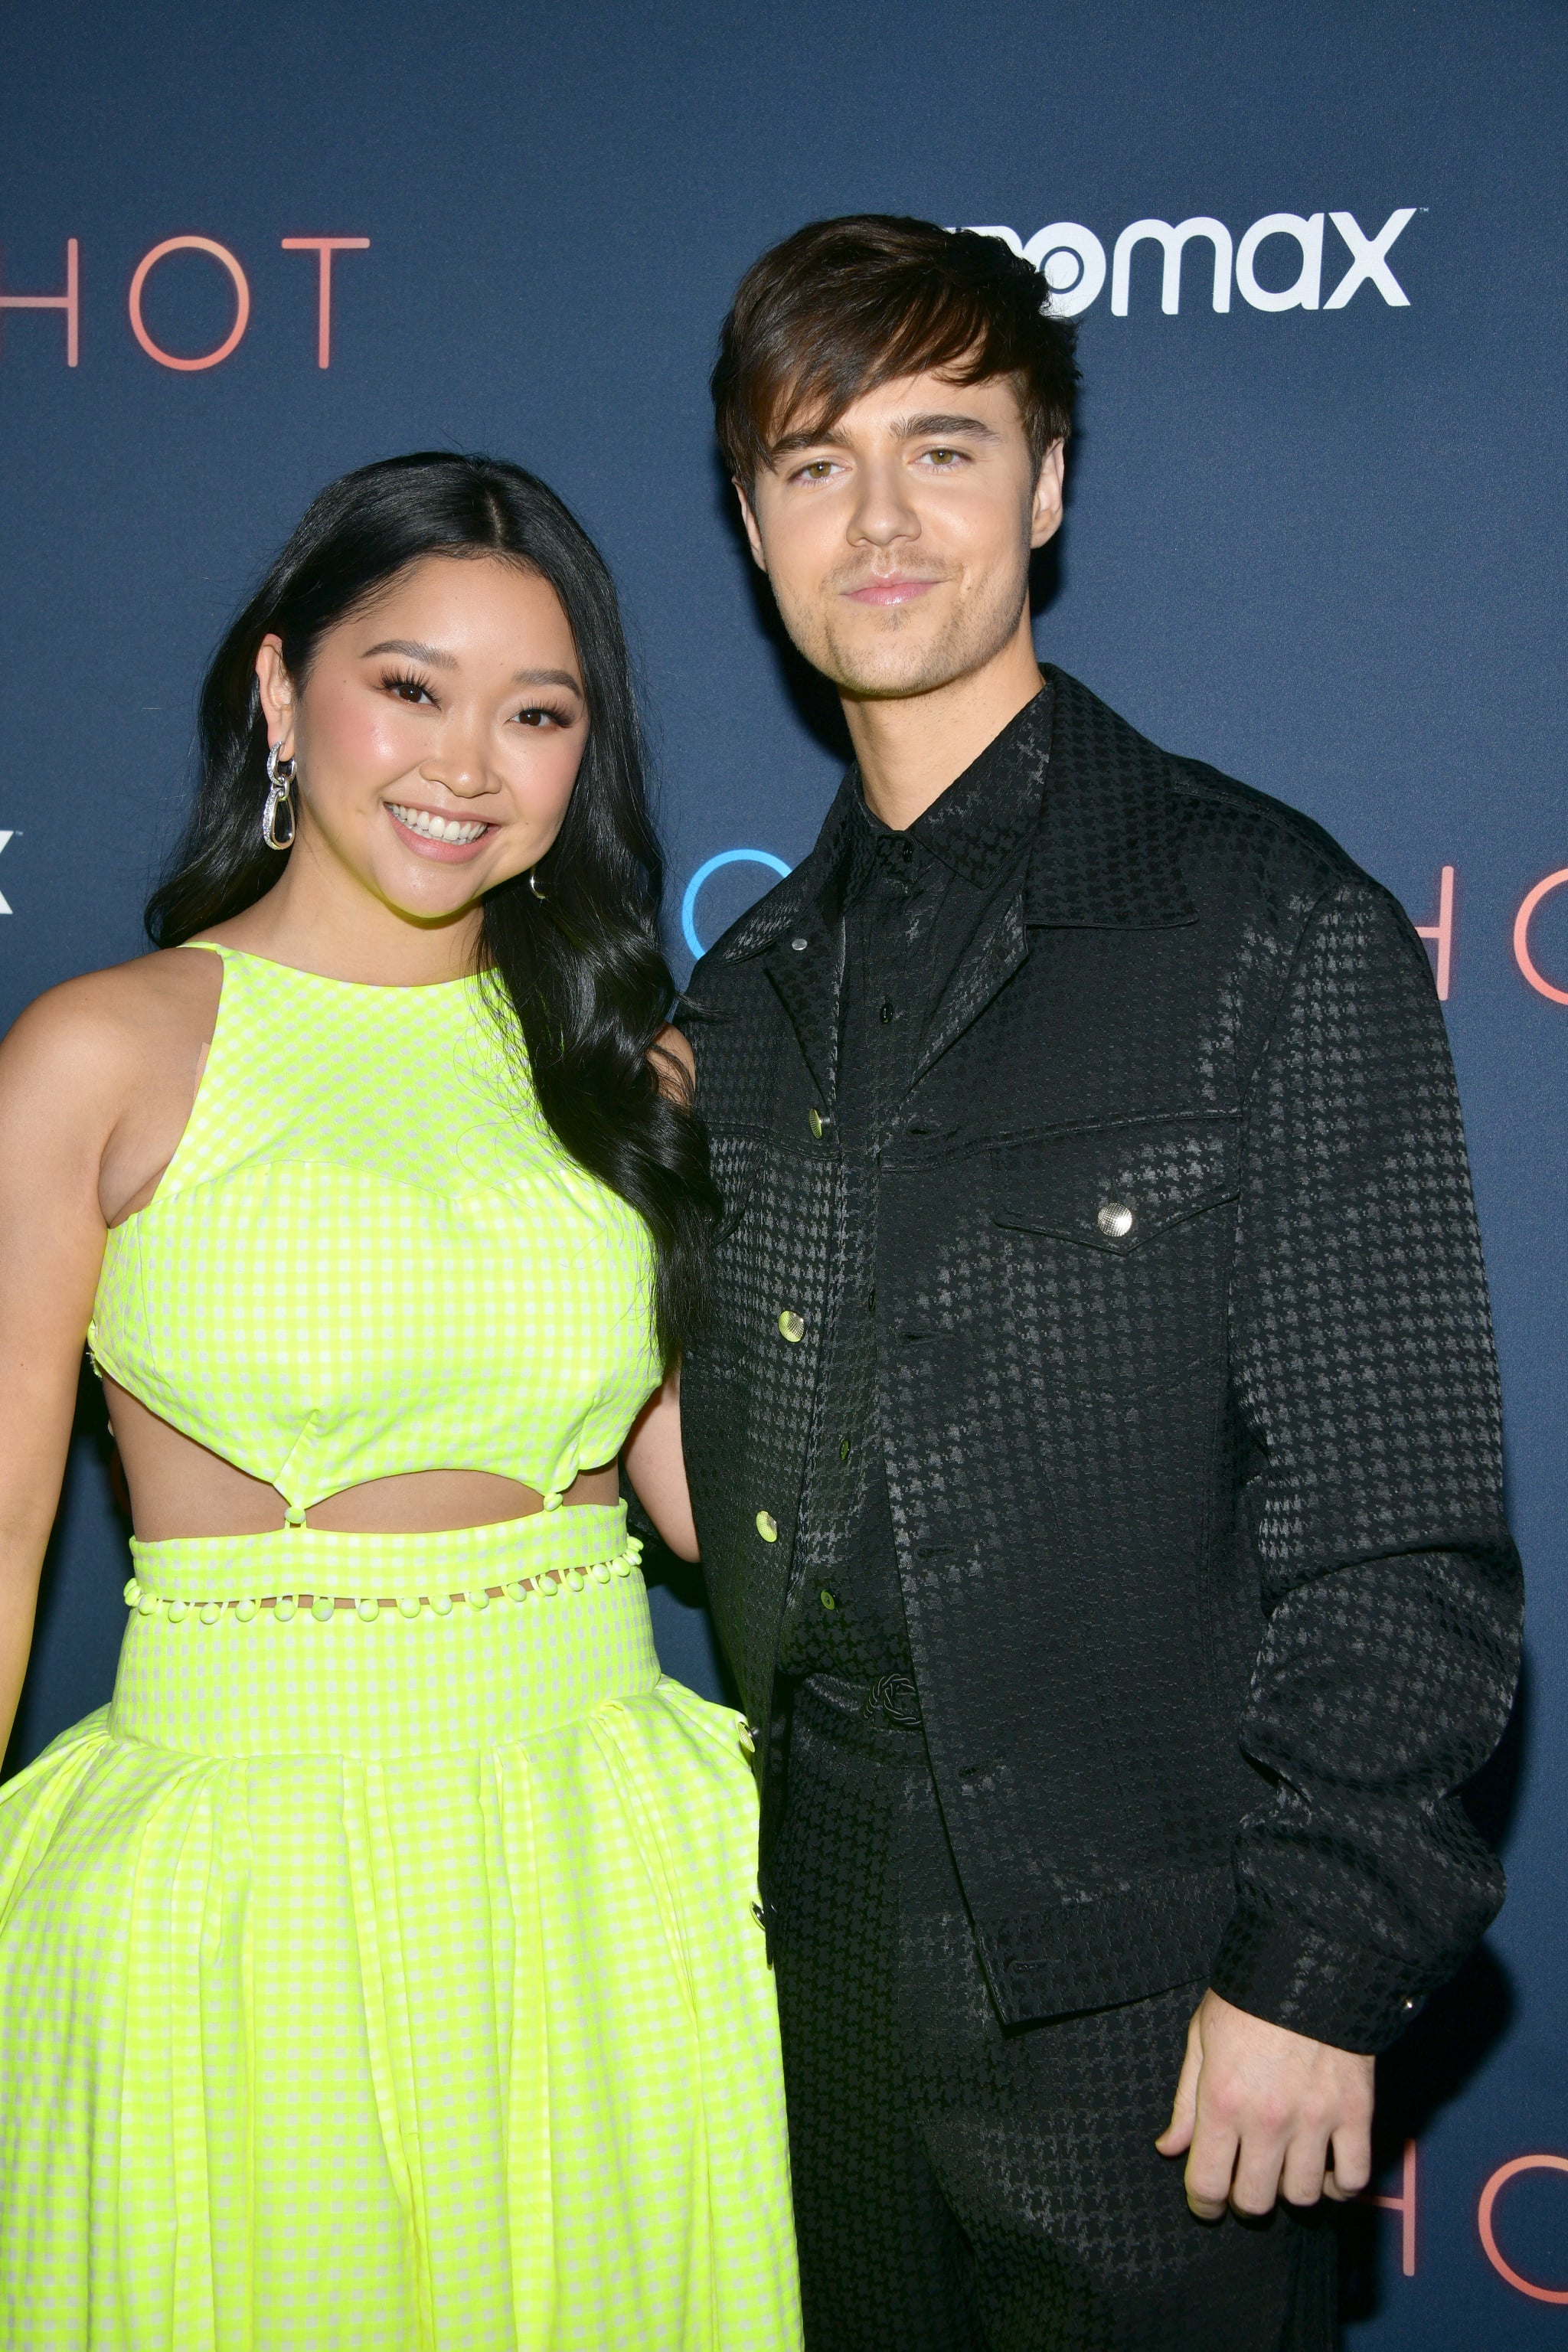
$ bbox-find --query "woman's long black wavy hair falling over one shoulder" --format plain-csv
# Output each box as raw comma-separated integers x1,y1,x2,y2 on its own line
145,452,717,1357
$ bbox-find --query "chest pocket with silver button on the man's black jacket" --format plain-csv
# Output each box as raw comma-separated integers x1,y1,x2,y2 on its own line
990,1117,1241,1397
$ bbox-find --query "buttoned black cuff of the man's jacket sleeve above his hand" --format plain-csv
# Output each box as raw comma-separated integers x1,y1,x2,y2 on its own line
1208,1900,1432,2058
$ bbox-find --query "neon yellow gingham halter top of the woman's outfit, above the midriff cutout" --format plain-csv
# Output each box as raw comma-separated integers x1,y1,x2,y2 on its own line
87,941,661,1524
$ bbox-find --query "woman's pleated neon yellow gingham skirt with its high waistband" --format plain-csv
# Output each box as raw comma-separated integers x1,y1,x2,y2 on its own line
0,1510,799,2352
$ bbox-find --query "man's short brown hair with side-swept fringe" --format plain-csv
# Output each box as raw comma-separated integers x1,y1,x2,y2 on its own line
712,211,1079,489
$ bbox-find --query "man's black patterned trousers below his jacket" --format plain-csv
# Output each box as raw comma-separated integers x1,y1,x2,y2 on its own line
769,1677,1335,2352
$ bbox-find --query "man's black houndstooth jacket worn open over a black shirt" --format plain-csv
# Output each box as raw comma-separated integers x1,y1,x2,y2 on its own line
681,671,1521,2051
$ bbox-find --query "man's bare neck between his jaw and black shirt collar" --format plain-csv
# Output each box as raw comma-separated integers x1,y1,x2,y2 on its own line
844,612,1039,832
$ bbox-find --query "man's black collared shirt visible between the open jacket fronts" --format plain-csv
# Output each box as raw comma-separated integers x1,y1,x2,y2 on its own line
778,687,1050,1681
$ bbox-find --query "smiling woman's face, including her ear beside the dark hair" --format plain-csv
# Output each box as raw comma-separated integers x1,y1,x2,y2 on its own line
256,555,588,922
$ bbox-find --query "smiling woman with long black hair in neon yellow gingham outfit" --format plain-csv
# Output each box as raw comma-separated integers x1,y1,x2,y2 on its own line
0,456,797,2352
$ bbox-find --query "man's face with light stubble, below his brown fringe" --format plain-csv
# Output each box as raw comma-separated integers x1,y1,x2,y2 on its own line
740,374,1063,698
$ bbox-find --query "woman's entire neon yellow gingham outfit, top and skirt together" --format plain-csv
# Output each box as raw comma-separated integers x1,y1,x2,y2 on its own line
0,957,799,2352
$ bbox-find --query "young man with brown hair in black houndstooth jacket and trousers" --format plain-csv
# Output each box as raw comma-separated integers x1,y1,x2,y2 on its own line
684,217,1519,2352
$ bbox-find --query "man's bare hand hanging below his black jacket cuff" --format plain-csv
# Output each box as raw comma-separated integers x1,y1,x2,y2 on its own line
1155,1992,1373,2220
